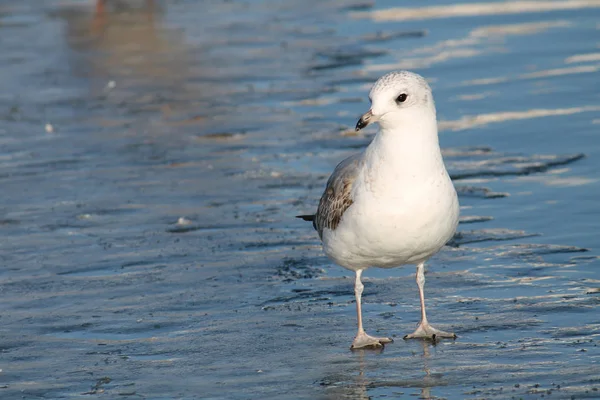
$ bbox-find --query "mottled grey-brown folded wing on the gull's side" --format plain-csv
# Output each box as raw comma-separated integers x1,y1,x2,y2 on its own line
313,153,363,238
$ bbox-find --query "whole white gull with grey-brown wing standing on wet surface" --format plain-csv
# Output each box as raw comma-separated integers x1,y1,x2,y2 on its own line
297,71,459,349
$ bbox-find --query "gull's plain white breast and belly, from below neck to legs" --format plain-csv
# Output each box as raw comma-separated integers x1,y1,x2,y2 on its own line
323,122,459,270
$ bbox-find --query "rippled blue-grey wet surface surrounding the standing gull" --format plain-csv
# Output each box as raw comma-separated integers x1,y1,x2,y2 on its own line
0,0,600,399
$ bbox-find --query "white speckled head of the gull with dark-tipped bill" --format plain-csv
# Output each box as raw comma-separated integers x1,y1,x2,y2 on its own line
356,71,435,131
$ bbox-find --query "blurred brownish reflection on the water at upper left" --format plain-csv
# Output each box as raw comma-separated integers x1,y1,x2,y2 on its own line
56,0,191,99
